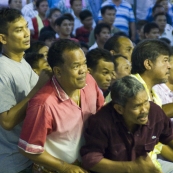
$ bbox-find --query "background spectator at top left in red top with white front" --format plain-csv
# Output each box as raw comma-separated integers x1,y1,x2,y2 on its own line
32,0,49,40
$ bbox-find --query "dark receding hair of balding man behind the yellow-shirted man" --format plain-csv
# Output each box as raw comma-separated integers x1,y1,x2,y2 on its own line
104,35,127,53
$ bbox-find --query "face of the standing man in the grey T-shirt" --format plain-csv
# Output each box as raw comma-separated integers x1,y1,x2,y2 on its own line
3,16,30,53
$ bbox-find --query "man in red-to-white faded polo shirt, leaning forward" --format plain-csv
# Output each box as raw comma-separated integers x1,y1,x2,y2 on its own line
18,39,104,173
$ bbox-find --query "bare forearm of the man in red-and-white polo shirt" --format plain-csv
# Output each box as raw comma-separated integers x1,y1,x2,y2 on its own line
20,149,87,173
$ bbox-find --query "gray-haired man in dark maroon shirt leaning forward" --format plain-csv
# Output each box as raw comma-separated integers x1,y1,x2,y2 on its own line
81,76,173,173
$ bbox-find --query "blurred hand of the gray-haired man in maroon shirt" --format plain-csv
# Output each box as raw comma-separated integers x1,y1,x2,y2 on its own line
132,155,162,173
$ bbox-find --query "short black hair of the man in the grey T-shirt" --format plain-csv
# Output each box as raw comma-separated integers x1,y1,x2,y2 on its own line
0,8,22,35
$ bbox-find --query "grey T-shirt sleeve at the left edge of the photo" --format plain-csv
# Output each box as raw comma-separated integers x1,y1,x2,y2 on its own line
0,74,17,113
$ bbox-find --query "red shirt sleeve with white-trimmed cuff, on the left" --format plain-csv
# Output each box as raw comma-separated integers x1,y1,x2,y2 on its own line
18,102,52,154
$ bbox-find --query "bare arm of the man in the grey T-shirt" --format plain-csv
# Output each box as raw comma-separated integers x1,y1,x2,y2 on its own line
0,70,50,130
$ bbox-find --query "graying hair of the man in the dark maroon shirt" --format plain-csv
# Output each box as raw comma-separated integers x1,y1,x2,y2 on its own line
111,76,145,107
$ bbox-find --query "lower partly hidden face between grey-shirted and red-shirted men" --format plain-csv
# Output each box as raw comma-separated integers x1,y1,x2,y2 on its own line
33,58,51,75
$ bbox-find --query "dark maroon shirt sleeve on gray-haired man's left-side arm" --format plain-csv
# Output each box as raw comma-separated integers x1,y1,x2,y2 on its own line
80,115,108,169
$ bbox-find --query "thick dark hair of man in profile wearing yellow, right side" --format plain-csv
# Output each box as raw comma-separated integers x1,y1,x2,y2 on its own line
131,39,171,74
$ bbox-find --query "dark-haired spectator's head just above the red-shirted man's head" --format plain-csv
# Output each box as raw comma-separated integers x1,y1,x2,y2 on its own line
38,31,56,47
